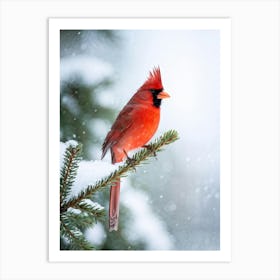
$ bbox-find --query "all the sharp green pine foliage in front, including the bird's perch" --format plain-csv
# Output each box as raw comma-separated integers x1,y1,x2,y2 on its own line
60,130,178,250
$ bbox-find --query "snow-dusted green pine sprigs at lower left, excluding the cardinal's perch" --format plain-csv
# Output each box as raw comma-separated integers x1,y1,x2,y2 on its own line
60,144,105,250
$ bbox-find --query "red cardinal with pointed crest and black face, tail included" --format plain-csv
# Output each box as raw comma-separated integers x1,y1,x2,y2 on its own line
102,68,170,231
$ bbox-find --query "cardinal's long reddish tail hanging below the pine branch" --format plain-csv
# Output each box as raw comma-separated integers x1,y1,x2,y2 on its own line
109,179,121,231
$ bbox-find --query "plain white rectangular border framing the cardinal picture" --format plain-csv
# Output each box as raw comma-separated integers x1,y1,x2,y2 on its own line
49,18,231,262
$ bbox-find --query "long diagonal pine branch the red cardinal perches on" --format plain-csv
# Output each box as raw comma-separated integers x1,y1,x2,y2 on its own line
60,130,179,213
